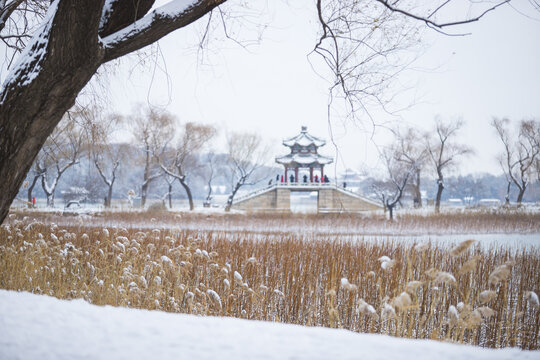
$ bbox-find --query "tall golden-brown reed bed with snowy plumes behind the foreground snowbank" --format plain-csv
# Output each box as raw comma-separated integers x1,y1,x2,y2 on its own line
0,220,540,349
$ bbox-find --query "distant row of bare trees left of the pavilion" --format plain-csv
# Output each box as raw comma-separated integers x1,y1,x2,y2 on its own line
18,106,270,210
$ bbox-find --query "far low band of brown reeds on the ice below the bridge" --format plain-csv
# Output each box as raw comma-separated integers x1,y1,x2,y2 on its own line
11,208,540,235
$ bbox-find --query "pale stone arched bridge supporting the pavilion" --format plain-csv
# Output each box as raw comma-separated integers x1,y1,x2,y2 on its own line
232,183,382,213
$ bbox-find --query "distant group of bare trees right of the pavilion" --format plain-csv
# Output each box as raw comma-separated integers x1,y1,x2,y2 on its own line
364,118,540,219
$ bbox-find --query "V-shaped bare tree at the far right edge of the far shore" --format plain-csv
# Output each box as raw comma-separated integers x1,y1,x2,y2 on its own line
491,118,540,206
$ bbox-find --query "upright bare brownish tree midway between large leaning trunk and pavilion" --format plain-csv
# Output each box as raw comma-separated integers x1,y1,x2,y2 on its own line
130,108,174,208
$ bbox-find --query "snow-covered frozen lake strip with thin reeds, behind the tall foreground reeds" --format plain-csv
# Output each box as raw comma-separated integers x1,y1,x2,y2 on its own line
8,212,540,251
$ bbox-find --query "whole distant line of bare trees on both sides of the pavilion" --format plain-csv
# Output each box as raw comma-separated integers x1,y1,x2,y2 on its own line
15,106,540,219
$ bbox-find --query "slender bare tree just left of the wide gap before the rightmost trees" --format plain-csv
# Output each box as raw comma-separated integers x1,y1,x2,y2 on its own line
425,119,472,213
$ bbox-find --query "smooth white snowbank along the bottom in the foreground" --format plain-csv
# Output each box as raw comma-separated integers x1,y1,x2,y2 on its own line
0,290,540,360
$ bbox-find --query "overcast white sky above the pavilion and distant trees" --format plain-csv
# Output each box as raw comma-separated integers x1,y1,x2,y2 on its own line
106,0,540,178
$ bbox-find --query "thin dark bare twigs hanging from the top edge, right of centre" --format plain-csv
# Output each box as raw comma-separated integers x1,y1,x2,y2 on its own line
312,0,507,122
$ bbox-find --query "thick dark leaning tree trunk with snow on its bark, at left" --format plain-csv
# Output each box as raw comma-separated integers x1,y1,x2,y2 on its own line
0,0,103,221
